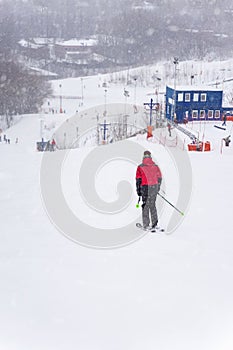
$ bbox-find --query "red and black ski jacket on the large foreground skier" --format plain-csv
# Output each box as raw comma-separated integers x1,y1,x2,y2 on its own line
136,157,162,186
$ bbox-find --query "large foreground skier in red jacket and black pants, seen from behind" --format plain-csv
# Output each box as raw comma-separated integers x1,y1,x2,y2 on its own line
136,151,162,232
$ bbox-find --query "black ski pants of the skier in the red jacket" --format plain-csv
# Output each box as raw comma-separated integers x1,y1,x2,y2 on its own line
141,185,158,227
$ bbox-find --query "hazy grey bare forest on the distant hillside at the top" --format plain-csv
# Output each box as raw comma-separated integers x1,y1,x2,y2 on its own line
0,0,233,64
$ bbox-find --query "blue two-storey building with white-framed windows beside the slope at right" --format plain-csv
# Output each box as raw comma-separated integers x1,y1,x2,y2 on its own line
166,86,227,123
